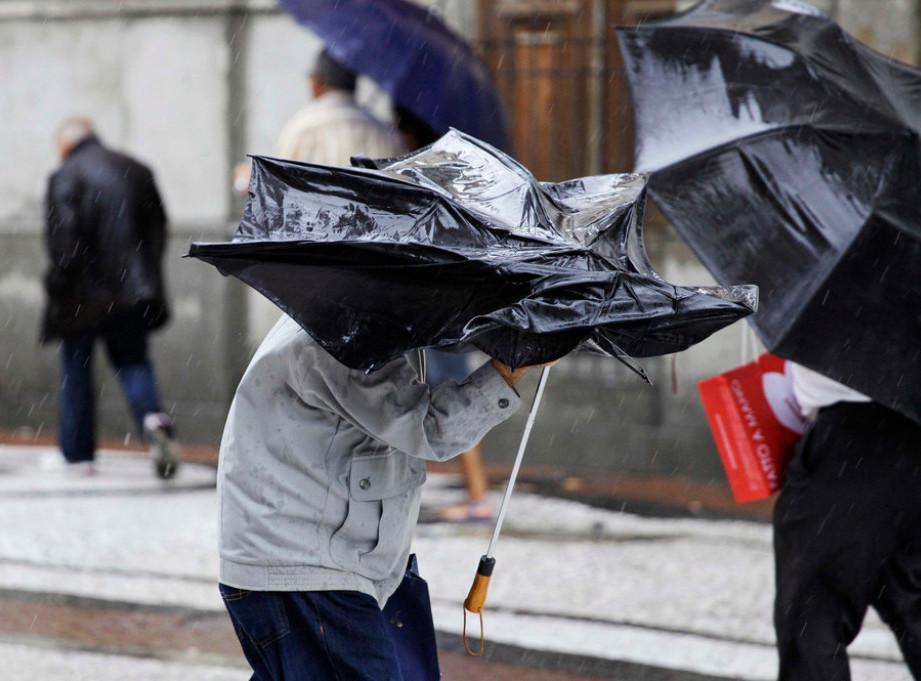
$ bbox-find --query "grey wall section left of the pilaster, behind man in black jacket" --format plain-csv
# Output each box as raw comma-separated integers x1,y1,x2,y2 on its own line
0,2,245,442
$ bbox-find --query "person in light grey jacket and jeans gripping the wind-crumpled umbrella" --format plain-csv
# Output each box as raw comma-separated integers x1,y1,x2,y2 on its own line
218,316,544,681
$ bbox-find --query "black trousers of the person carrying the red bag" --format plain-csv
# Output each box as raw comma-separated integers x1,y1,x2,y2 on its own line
774,403,921,681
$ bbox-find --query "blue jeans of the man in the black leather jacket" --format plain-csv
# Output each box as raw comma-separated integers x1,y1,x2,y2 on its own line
60,310,161,463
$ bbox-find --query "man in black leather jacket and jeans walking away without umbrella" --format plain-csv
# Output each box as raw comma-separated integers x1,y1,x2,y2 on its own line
42,118,178,478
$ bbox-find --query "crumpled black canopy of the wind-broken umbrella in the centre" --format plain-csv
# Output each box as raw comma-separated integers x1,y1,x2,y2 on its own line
189,131,757,370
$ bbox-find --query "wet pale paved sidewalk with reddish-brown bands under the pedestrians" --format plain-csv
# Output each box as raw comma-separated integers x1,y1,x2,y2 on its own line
0,445,910,681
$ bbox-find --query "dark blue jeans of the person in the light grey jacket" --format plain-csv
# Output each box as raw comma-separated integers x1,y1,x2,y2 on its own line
220,584,403,681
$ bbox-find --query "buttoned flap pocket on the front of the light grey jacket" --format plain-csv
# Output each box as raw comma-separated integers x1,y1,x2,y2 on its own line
329,451,425,580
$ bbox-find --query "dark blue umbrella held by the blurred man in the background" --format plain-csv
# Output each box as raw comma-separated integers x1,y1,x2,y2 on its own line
278,0,511,152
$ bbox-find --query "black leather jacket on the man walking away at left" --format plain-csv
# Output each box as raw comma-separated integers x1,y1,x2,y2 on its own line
42,137,168,340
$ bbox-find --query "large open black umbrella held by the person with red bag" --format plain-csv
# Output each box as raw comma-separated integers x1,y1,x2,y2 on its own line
618,0,921,421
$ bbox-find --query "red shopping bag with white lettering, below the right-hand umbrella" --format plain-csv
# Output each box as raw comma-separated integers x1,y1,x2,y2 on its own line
697,353,807,503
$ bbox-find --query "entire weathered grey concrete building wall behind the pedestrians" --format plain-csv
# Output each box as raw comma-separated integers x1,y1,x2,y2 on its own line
0,0,917,479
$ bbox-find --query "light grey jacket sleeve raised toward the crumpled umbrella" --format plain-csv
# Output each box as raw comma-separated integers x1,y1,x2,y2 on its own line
290,343,521,461
